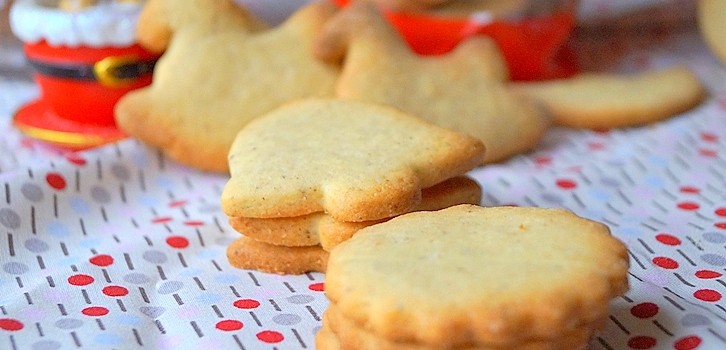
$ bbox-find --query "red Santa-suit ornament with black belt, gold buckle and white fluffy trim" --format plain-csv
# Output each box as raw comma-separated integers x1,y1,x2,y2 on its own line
10,0,158,149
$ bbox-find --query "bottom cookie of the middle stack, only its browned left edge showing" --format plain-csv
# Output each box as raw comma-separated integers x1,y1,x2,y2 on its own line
227,236,328,275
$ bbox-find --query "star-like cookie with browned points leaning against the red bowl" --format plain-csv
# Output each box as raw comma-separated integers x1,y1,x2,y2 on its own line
315,2,549,163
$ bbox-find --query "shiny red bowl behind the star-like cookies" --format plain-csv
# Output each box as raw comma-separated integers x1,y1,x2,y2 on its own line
333,0,578,80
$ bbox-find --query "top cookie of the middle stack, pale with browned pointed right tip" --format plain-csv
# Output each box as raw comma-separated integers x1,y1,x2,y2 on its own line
222,99,484,222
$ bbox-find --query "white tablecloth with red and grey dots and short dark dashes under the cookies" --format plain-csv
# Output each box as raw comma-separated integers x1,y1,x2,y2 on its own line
0,1,726,350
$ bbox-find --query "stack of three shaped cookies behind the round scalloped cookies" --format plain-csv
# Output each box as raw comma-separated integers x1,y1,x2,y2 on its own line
222,99,484,274
